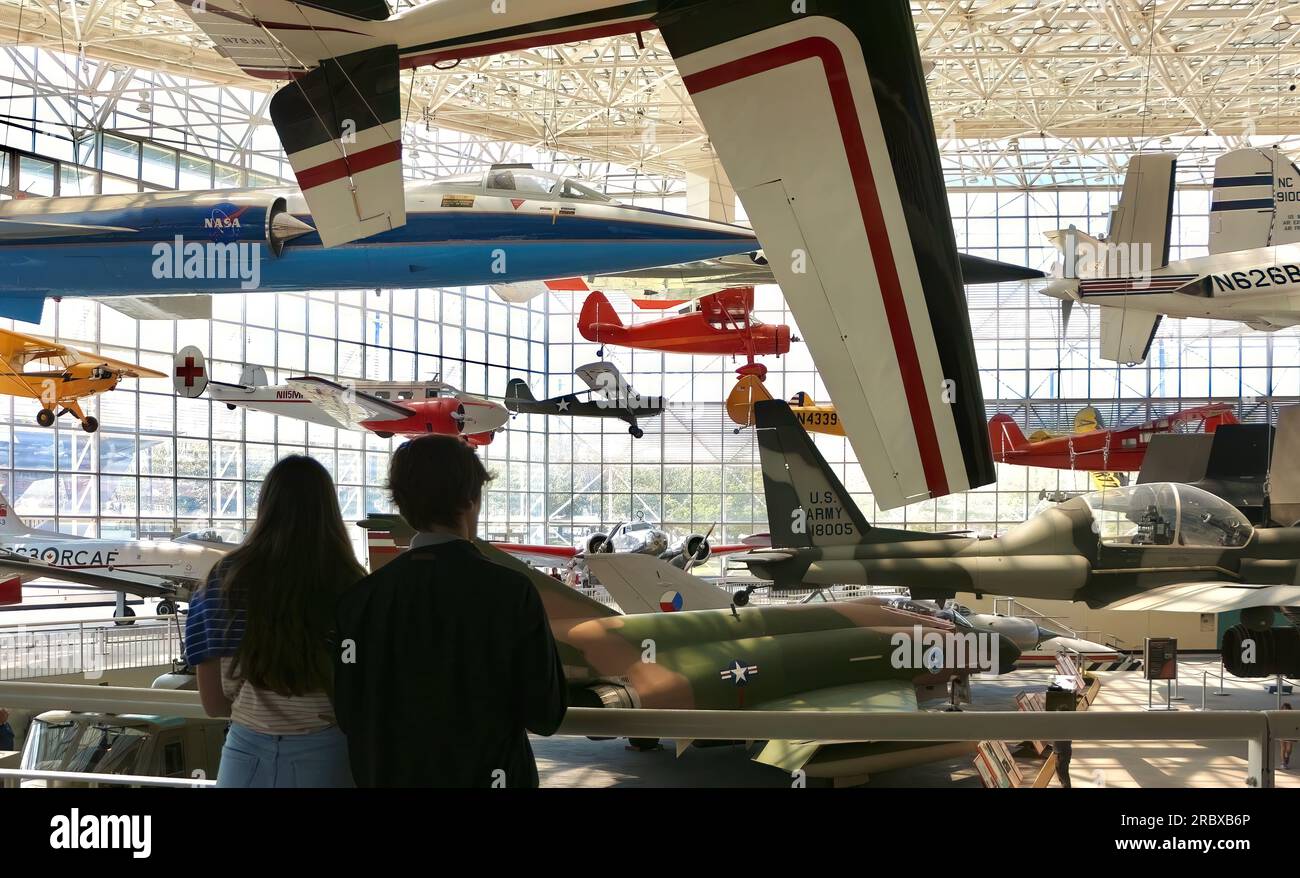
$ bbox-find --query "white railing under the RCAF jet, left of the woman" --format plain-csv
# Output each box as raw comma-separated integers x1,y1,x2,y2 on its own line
0,617,182,680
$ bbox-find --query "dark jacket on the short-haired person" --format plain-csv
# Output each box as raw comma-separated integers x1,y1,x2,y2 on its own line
334,540,568,787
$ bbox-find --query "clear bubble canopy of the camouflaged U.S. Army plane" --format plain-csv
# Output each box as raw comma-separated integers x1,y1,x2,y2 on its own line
1083,483,1255,549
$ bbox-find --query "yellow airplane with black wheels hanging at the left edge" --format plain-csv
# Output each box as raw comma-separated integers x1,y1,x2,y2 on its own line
0,329,166,433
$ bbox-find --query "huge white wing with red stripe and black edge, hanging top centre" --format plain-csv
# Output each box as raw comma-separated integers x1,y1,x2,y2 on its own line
659,0,995,509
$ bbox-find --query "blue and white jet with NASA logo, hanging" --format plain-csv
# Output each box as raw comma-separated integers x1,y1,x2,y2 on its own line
0,165,758,323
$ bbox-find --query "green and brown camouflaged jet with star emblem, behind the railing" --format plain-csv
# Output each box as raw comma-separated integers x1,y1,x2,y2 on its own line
351,522,1019,783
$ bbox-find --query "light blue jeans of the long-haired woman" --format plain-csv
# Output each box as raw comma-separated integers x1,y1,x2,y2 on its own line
217,722,355,787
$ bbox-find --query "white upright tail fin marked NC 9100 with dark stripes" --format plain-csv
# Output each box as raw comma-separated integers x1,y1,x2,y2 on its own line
1210,150,1300,256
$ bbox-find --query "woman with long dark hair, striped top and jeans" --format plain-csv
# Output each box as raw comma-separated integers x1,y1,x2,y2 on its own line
185,455,365,787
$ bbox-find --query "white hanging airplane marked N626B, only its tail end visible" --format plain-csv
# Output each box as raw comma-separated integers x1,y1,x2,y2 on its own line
1044,148,1300,364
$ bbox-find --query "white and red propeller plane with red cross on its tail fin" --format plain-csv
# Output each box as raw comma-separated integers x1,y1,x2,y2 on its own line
172,345,510,446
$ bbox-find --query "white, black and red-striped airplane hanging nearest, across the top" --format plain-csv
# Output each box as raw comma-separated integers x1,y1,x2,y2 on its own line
162,0,995,509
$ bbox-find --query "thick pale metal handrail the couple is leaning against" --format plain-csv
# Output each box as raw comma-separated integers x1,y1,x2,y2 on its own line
0,683,1300,787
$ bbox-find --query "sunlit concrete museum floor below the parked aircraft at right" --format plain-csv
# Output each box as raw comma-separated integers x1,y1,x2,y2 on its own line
533,657,1300,787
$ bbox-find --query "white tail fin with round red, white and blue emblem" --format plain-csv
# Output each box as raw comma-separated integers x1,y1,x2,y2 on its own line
586,552,732,615
